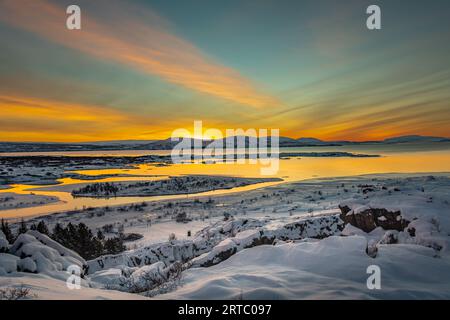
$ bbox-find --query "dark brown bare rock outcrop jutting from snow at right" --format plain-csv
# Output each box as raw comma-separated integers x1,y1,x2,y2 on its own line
339,205,409,232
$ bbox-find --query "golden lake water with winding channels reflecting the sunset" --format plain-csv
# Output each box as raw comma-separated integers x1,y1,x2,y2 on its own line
0,143,450,218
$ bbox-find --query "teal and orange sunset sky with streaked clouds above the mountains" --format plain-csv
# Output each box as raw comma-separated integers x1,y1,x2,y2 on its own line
0,0,450,142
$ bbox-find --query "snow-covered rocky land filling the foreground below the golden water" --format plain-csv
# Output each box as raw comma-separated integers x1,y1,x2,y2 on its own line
0,174,450,299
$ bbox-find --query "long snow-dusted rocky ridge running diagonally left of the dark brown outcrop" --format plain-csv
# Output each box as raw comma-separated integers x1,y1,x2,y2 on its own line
88,215,344,274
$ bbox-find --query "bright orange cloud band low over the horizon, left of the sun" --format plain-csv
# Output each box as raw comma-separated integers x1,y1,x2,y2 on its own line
0,95,176,142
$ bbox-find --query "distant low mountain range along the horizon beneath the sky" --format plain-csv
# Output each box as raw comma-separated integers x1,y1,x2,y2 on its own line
0,135,450,152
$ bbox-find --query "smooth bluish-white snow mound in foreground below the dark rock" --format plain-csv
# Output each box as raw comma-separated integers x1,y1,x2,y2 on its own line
158,236,450,300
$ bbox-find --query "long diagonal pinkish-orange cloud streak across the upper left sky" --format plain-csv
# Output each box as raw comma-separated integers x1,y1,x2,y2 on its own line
0,0,280,108
